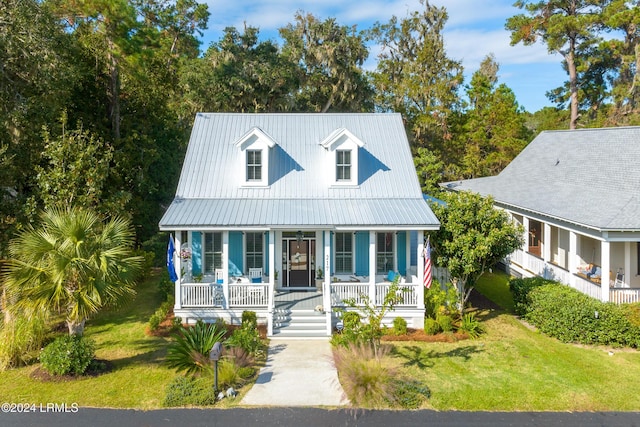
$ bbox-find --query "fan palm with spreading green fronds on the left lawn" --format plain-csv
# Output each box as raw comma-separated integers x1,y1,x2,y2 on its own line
4,208,142,335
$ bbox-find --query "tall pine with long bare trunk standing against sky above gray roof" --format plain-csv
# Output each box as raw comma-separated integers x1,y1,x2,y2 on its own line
505,0,608,129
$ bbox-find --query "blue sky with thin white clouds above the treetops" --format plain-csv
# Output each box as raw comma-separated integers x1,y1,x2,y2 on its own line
203,0,567,112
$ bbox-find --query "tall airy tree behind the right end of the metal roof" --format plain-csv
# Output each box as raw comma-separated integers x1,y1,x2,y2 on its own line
370,0,463,163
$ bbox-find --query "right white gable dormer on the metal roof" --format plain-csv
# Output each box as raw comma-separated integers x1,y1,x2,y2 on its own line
320,128,364,185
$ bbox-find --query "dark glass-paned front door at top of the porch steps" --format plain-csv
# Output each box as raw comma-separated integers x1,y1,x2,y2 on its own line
282,239,313,288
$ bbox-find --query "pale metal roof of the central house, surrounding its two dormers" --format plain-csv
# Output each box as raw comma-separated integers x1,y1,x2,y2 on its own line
160,113,439,230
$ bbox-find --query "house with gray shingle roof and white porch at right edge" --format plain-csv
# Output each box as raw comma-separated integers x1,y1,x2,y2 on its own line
443,127,640,303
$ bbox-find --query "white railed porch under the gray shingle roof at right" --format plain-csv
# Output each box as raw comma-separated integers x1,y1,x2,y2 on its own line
508,212,640,304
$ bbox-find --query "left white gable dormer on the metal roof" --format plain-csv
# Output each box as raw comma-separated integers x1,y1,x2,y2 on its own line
234,127,276,187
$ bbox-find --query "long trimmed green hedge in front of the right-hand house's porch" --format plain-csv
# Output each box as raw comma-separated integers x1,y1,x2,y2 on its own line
525,284,640,347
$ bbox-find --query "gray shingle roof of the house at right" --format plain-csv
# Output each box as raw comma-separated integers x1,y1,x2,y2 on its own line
443,127,640,230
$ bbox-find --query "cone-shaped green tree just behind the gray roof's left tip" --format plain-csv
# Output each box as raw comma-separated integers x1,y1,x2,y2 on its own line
457,55,530,178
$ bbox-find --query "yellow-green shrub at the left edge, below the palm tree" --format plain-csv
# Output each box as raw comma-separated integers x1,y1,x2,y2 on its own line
0,316,47,371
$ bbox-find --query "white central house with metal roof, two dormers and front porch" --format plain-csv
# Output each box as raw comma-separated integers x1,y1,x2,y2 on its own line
160,113,439,336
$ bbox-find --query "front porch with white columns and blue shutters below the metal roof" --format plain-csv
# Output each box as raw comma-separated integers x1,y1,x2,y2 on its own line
174,229,424,336
